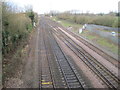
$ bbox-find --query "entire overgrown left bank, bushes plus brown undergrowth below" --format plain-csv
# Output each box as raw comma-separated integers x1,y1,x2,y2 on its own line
2,3,37,84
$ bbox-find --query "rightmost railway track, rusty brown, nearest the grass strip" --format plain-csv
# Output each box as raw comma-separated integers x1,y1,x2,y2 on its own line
48,19,120,68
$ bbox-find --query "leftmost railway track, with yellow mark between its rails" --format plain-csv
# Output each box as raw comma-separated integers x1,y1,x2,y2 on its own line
39,21,54,88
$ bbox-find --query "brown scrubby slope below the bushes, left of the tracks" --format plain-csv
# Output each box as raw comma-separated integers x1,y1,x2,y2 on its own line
3,30,35,88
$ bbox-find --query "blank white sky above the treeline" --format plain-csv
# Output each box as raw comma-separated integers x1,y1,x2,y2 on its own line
9,0,119,13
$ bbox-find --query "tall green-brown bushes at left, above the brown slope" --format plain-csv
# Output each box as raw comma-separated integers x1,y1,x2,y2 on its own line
2,3,32,55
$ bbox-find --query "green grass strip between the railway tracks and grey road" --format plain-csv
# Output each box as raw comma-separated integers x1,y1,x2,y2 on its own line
52,17,120,55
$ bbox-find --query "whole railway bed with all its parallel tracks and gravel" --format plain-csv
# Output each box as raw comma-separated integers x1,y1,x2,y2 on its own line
4,17,119,89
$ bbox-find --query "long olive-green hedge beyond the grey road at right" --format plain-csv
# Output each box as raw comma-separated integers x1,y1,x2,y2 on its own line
57,13,120,27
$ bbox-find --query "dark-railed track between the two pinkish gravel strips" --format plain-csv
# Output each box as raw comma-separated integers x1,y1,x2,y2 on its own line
49,24,119,89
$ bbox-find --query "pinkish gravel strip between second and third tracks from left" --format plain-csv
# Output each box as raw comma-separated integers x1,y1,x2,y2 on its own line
56,33,106,88
